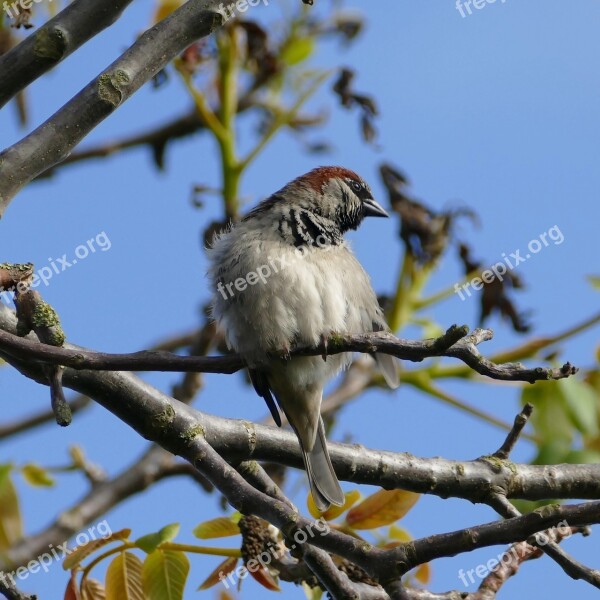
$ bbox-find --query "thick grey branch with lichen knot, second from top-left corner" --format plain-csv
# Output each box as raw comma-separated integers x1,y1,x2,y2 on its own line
0,0,223,216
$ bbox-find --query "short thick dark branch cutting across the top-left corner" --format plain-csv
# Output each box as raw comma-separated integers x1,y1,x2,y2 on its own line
0,0,132,108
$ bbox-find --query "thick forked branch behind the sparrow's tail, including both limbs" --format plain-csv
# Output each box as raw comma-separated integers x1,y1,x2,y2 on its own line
0,308,600,589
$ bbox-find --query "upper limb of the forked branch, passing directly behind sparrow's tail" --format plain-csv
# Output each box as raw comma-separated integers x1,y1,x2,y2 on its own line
0,305,600,503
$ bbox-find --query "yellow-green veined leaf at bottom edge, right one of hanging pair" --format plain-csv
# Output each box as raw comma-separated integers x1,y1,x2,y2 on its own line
142,550,190,600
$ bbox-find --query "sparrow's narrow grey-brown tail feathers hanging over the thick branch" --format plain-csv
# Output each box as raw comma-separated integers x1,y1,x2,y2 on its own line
300,417,345,512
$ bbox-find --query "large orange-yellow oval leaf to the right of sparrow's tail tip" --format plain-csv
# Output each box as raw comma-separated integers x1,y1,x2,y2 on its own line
346,490,420,529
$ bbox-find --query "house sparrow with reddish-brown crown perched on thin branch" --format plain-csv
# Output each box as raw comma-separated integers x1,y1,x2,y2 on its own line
208,167,398,512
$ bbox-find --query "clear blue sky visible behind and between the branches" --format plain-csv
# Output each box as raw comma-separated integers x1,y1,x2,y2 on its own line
0,0,600,600
